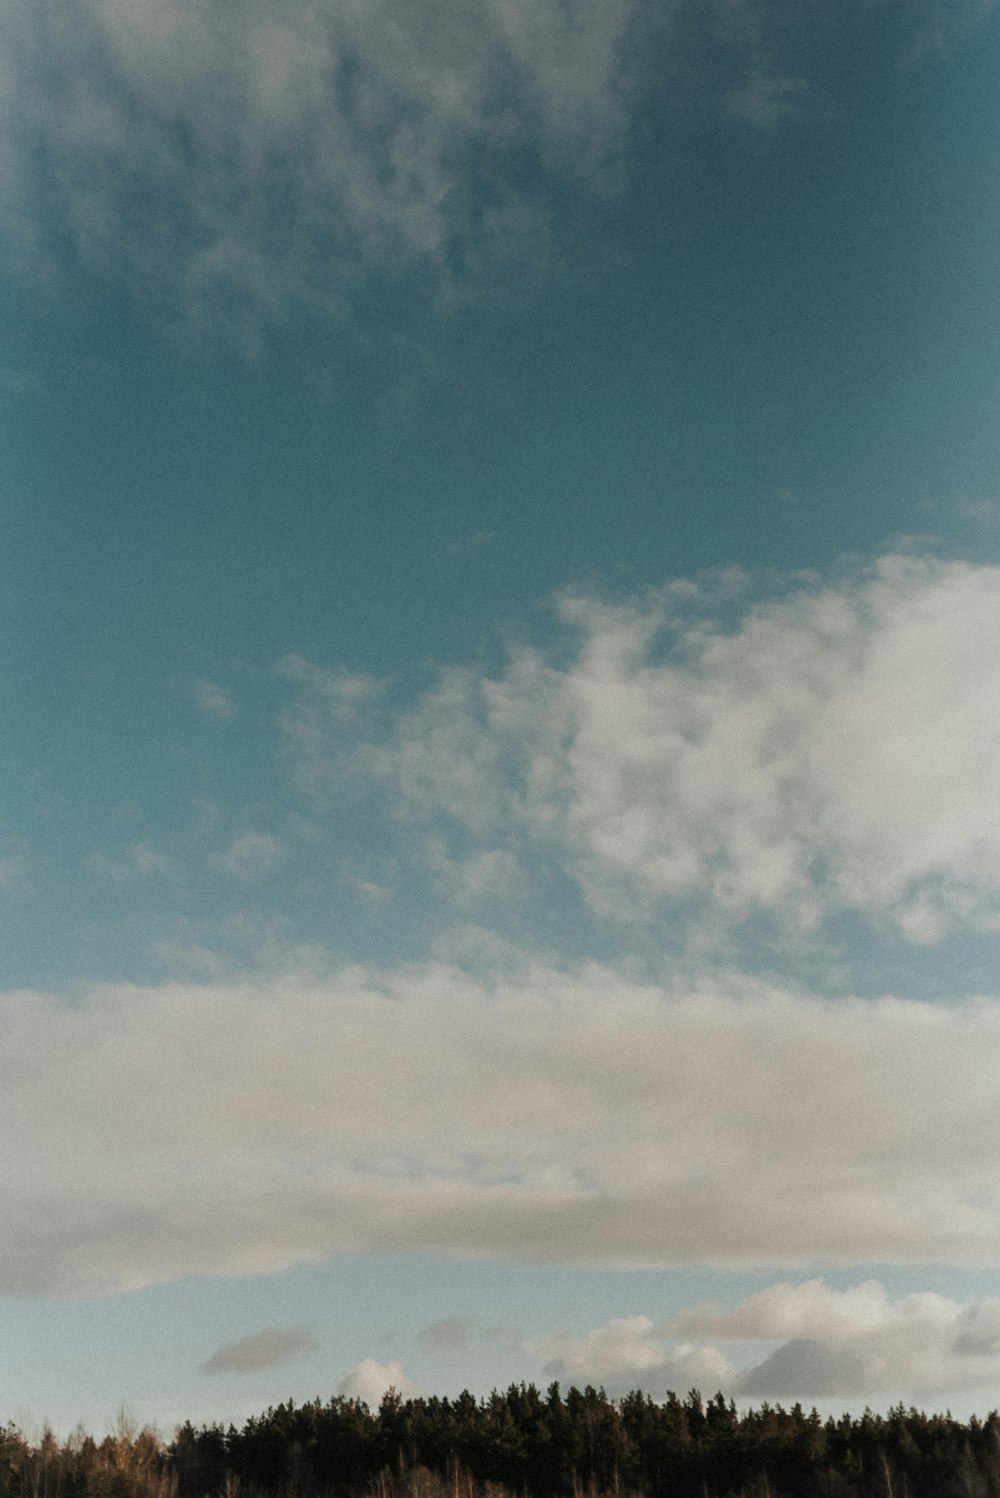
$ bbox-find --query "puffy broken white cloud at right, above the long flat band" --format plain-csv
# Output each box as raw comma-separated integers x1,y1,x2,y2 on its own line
286,557,1000,944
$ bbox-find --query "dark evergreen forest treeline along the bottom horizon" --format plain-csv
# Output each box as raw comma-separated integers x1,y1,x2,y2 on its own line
0,1383,1000,1498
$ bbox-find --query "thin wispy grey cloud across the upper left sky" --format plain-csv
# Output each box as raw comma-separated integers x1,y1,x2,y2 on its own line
0,0,636,345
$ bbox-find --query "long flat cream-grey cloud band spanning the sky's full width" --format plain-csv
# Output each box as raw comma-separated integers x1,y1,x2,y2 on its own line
0,963,1000,1300
